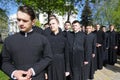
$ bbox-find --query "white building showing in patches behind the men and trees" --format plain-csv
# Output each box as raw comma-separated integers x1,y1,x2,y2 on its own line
8,13,77,35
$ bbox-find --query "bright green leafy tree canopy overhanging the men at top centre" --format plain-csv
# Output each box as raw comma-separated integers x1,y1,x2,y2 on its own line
16,0,76,20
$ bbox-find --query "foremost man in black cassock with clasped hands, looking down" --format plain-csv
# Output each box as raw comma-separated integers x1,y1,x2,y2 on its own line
2,6,52,80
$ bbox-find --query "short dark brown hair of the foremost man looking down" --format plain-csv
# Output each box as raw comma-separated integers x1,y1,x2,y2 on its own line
18,5,35,20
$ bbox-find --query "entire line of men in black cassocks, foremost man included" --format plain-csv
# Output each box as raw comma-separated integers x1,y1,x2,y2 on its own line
2,6,117,80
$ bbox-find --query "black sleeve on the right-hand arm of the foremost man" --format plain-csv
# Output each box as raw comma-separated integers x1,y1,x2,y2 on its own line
32,38,53,75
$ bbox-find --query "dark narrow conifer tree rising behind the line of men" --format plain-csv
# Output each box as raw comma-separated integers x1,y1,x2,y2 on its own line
80,0,93,26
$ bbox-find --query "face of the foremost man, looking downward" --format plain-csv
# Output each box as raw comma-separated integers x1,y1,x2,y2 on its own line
17,11,34,32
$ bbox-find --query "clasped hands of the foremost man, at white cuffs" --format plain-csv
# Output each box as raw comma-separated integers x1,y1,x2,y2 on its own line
13,69,33,80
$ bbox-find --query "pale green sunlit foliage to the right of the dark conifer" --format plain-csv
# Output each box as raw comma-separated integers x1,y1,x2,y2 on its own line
93,0,120,29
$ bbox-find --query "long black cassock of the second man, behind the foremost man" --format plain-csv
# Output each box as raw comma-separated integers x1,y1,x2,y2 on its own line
46,31,70,80
